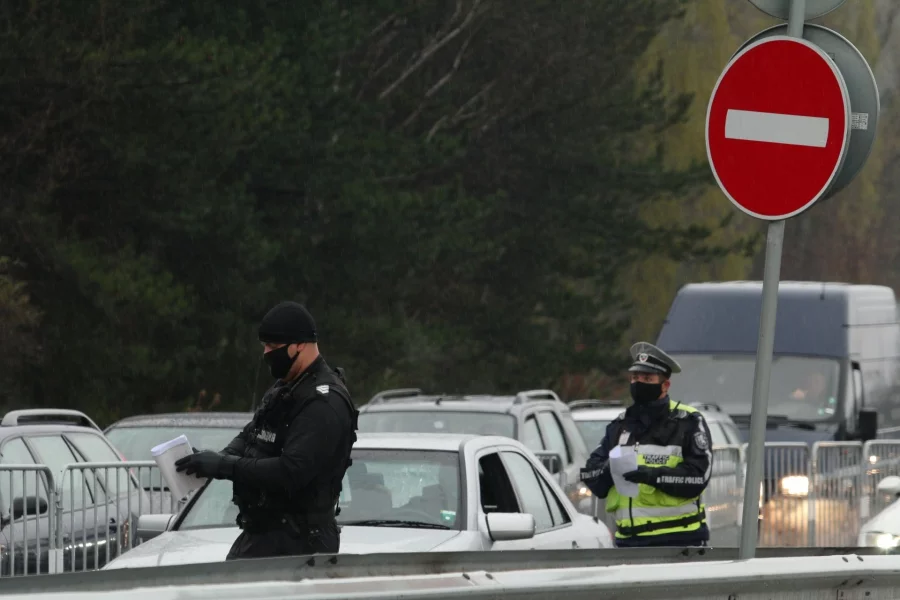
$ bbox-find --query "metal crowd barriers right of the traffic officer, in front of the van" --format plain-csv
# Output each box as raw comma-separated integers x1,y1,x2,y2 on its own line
580,440,900,547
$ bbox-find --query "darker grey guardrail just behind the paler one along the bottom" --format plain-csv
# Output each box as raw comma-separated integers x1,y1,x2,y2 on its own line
0,548,884,600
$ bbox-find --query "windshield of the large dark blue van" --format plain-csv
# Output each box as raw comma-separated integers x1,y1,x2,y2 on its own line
670,354,840,421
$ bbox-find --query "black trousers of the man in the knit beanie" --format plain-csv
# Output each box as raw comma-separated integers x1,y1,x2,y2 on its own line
225,521,341,560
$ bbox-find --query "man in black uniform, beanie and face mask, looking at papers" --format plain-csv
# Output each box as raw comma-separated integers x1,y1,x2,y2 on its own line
175,302,359,560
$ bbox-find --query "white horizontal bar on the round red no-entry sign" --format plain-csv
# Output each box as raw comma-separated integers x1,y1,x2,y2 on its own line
725,108,828,148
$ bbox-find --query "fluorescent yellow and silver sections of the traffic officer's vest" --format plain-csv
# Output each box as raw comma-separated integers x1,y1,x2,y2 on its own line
606,402,706,539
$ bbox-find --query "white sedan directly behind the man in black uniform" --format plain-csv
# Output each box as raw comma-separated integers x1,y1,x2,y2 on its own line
105,433,613,569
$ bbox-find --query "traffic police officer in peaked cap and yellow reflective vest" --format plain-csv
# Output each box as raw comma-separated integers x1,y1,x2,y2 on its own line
581,342,712,547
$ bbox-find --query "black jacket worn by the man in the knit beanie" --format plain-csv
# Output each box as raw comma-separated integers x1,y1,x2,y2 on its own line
223,356,358,519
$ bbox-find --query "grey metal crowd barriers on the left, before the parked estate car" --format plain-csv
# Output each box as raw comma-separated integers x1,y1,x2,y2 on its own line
0,461,188,577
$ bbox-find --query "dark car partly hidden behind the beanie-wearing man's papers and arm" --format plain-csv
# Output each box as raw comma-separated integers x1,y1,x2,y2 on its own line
104,412,253,513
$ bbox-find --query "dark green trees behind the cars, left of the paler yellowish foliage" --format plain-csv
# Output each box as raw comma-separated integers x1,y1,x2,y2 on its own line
0,0,740,420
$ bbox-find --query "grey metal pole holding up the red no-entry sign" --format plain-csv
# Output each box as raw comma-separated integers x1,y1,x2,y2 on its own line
738,0,806,559
